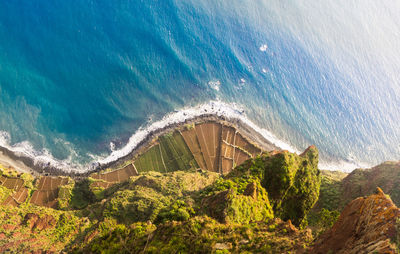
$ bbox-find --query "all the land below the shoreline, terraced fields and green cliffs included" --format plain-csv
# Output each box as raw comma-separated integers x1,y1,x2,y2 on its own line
0,122,400,253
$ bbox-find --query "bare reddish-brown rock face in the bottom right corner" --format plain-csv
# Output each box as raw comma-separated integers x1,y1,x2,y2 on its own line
311,188,400,253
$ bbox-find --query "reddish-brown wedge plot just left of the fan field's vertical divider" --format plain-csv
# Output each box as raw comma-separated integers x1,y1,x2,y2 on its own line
195,123,222,172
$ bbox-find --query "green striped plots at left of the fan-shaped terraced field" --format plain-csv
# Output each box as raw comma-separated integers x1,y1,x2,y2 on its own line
134,131,198,172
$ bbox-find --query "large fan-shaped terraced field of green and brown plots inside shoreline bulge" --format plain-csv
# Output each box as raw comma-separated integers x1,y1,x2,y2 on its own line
134,122,261,174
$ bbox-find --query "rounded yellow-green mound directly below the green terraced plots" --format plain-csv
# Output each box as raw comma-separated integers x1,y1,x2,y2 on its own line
103,171,218,224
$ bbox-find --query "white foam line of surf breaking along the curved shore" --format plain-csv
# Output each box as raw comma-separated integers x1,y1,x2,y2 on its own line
0,101,368,173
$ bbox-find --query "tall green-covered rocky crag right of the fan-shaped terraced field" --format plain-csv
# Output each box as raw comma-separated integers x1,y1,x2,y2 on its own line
228,146,321,226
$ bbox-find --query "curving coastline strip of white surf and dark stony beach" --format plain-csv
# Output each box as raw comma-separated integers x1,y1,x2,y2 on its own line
0,101,376,177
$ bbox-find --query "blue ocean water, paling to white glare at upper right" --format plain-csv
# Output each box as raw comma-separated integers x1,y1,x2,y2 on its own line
0,0,400,172
